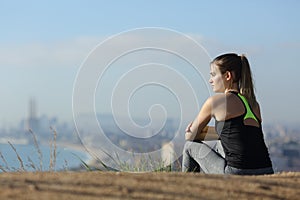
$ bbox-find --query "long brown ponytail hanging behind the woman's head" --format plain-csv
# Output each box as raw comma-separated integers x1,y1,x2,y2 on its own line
239,54,257,108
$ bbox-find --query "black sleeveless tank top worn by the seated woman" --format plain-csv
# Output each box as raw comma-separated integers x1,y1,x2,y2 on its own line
215,93,272,169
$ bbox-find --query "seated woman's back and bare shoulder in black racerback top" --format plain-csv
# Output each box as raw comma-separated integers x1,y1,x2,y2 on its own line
215,92,271,169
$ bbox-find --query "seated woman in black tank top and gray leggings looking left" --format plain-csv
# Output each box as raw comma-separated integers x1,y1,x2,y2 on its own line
182,53,274,175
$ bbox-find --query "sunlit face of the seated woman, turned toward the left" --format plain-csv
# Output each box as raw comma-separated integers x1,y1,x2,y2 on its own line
209,63,225,92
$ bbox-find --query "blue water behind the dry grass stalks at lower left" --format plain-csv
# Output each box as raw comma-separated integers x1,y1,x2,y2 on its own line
0,144,89,172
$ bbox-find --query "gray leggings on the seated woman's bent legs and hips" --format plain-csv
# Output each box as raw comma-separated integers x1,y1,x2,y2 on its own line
182,140,274,175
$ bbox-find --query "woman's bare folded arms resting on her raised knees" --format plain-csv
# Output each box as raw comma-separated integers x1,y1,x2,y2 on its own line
185,97,218,140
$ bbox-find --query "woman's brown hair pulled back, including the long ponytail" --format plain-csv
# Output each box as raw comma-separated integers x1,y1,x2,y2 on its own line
212,53,257,107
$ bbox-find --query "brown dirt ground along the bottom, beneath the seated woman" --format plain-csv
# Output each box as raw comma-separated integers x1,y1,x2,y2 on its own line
0,172,300,200
